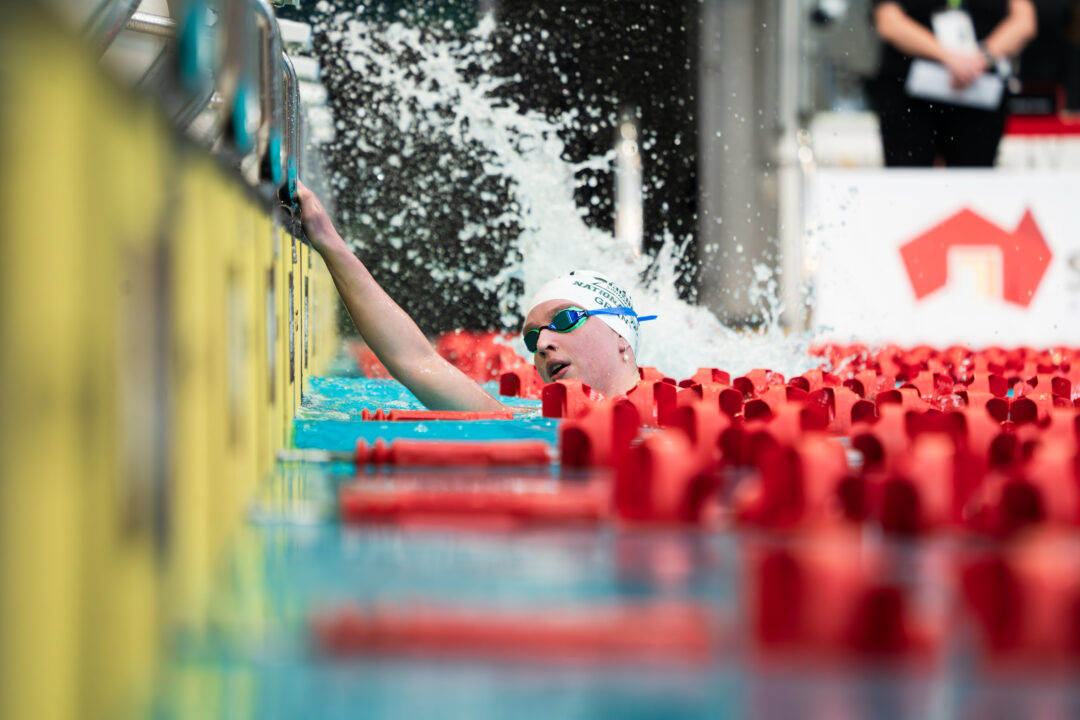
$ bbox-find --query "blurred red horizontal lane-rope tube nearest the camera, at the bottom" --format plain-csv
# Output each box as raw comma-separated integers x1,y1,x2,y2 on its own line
311,604,717,665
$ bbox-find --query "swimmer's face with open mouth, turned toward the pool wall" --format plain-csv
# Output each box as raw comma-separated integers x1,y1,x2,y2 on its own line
523,300,637,395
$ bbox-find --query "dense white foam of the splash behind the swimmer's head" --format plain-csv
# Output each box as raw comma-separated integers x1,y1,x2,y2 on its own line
328,13,818,378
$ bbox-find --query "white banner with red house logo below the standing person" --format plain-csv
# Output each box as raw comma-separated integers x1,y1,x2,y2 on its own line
806,169,1080,347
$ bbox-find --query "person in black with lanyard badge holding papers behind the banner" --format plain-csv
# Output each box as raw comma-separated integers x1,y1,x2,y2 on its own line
869,0,1036,167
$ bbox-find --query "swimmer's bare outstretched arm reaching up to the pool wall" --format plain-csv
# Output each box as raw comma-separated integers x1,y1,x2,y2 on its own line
297,182,507,410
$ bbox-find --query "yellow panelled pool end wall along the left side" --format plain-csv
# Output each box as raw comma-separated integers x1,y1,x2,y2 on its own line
0,3,338,719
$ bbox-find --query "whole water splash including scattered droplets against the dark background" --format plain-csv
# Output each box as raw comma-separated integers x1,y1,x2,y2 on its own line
308,2,813,378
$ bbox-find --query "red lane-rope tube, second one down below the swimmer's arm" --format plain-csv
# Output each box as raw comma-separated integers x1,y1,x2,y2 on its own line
355,438,552,466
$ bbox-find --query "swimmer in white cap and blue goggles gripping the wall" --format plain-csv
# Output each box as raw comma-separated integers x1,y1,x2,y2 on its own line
297,182,656,410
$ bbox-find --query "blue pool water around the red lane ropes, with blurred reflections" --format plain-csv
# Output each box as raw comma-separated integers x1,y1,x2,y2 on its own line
158,378,1080,720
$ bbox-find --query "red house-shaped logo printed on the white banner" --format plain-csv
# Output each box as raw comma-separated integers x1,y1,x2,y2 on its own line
900,208,1053,308
